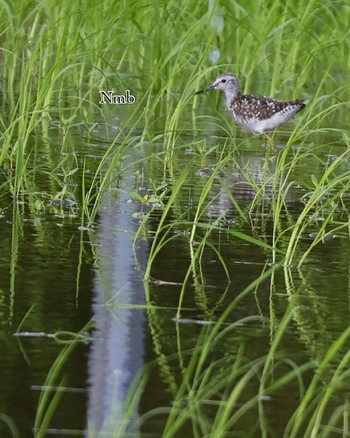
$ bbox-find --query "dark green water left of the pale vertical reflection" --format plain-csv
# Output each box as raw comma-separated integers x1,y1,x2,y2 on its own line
0,200,93,437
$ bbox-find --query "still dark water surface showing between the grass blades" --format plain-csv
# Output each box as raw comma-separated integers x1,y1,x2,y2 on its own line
0,120,350,437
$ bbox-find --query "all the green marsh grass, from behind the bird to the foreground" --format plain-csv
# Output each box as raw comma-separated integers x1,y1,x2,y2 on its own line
0,0,350,437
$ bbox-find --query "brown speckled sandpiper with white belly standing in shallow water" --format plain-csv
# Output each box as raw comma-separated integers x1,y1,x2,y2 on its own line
195,73,305,140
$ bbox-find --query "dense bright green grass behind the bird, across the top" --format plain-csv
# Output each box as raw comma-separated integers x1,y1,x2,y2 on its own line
0,1,348,225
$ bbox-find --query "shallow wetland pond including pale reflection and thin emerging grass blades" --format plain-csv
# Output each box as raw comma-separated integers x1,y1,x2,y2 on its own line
0,102,350,437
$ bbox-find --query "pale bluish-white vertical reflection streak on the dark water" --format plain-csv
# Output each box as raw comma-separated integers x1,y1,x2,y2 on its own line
88,156,147,436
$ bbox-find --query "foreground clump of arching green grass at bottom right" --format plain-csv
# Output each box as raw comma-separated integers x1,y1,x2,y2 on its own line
84,274,349,438
